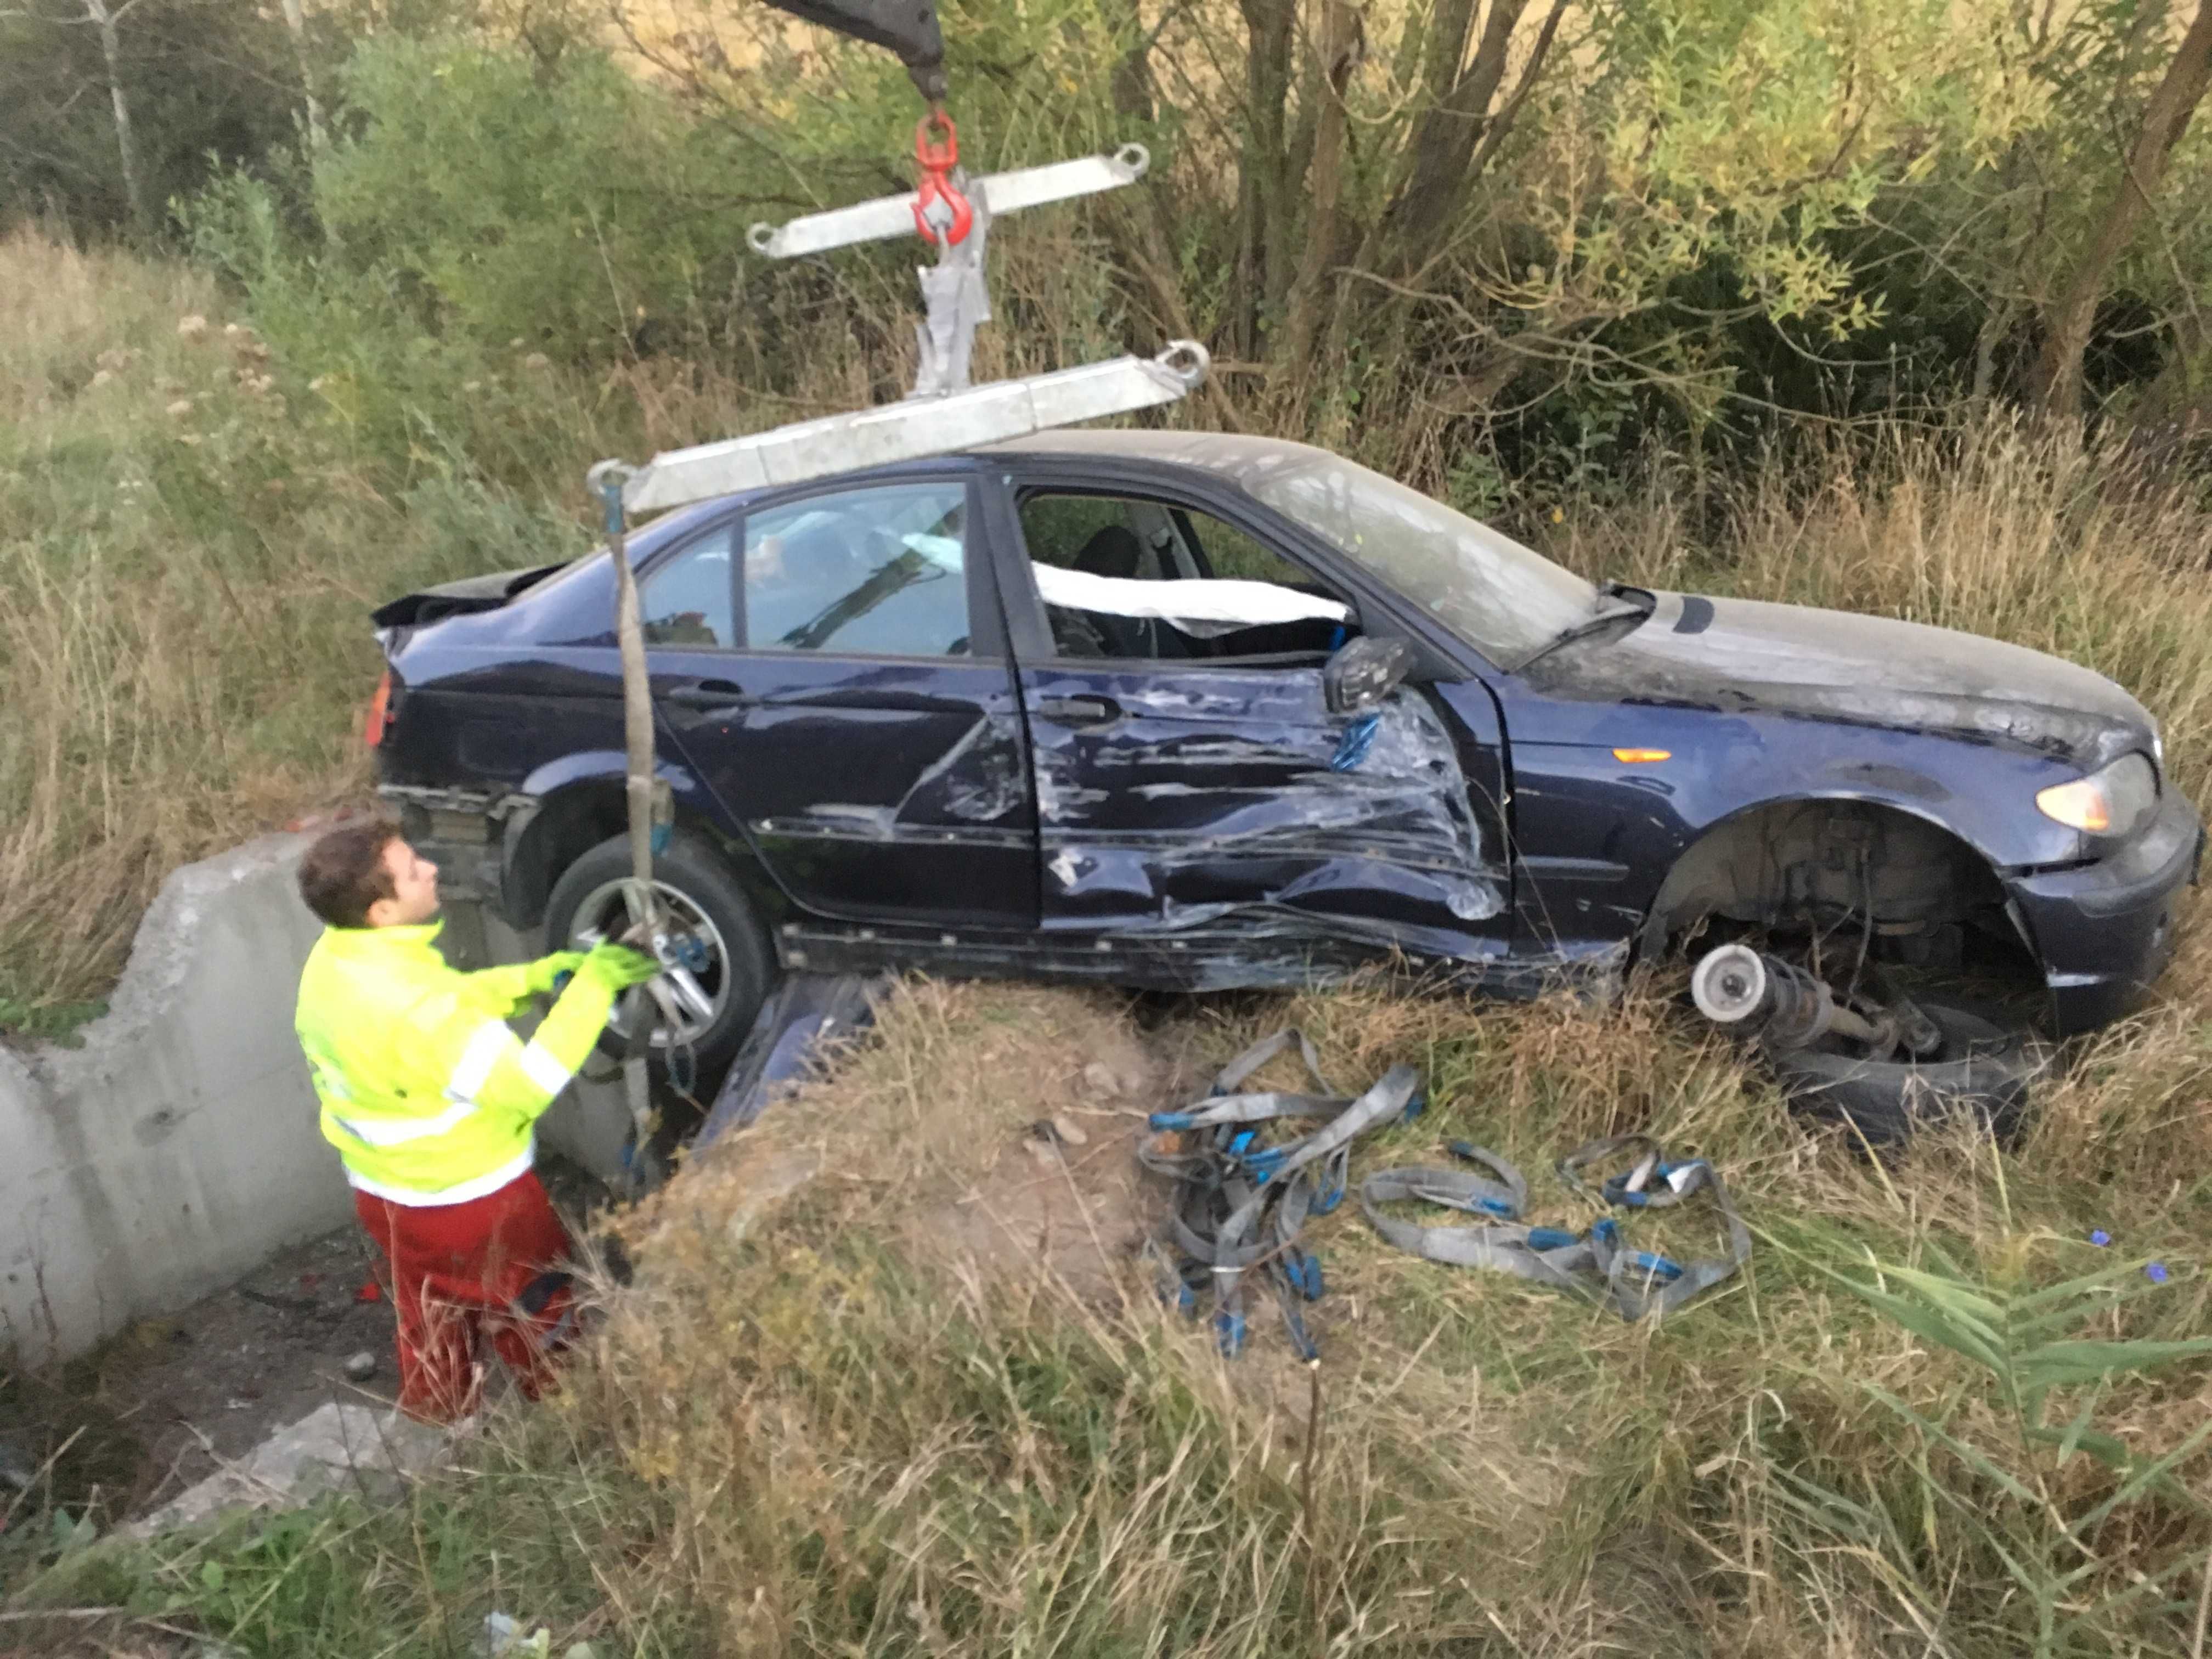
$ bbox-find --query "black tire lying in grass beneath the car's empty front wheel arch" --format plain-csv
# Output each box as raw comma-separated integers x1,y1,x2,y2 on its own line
1768,1002,2044,1148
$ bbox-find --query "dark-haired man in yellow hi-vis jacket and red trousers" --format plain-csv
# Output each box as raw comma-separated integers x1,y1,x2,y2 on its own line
296,821,657,1423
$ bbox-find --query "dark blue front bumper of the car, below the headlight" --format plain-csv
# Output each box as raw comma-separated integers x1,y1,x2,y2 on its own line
2006,789,2205,1035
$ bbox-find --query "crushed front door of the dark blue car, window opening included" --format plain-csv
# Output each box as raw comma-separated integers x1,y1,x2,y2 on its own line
1000,473,1509,980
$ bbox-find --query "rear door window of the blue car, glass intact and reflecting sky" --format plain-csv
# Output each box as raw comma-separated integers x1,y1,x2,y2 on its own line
743,480,969,657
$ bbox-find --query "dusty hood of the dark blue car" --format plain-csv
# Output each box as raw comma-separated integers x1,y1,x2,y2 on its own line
1528,593,2157,770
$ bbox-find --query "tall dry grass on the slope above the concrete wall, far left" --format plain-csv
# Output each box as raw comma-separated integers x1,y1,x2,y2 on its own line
0,230,404,1013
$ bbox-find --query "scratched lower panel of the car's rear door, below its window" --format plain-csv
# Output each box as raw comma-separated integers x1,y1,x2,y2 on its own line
652,650,1037,929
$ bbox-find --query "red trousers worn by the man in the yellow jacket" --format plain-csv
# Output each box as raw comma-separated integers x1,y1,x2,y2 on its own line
354,1175,573,1423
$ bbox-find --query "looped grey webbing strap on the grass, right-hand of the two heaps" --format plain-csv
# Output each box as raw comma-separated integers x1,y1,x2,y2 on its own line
1361,1135,1752,1321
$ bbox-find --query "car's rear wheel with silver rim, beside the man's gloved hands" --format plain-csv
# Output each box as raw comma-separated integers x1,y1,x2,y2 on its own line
546,834,774,1086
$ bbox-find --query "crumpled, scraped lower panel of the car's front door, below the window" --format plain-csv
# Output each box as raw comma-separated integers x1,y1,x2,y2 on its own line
1022,664,1506,958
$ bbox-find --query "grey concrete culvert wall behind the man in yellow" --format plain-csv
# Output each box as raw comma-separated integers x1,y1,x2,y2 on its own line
0,836,626,1365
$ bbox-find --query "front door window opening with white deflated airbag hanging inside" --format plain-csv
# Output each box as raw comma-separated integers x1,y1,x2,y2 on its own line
1022,491,1358,662
